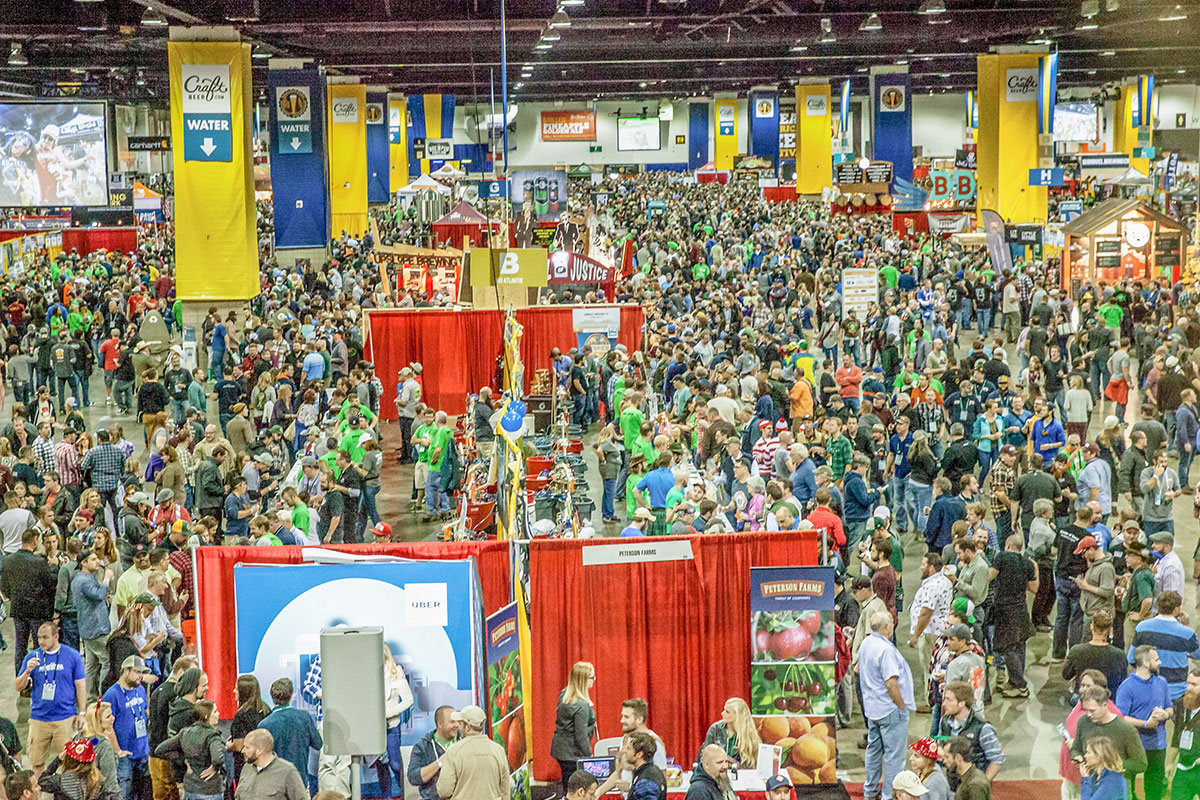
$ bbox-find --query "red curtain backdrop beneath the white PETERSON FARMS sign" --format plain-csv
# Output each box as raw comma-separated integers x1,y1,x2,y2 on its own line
527,531,817,781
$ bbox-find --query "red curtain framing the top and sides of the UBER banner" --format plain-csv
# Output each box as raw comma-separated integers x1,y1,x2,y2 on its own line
194,541,512,718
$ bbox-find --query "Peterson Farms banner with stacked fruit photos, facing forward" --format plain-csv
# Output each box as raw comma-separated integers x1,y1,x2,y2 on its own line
750,566,838,786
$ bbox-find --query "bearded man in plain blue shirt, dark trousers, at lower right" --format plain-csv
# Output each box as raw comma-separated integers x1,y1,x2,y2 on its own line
1116,644,1175,800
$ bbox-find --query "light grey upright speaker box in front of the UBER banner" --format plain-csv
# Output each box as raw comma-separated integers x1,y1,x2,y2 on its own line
320,627,388,756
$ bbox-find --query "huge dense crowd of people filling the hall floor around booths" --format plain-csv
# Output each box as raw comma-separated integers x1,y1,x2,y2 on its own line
0,165,1200,800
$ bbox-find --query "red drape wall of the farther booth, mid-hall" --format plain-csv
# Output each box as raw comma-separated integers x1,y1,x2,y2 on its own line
367,305,644,420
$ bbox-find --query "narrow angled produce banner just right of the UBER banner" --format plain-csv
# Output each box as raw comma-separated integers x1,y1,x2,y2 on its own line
484,603,529,798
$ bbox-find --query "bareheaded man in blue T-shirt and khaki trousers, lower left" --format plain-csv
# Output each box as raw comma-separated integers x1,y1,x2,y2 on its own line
16,622,88,780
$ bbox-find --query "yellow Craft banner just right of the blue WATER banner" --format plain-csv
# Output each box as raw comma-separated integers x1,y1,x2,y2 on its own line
329,83,367,236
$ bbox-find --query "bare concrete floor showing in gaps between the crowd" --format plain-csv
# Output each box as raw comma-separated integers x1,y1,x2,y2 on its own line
0,350,1200,781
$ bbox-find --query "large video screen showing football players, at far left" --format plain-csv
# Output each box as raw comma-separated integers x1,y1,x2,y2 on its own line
0,103,108,206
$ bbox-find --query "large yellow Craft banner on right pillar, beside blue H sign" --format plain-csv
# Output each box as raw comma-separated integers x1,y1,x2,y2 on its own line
976,53,1048,223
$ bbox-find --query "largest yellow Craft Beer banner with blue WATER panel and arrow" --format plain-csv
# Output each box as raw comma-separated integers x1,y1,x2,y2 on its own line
167,41,259,300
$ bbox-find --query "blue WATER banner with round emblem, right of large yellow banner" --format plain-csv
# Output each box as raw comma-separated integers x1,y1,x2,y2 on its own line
266,68,330,249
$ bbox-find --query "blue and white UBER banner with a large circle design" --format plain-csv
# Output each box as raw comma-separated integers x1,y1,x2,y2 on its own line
233,560,484,743
